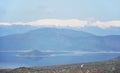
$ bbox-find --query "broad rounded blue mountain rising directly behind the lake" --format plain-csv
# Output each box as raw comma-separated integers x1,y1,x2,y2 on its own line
0,28,120,51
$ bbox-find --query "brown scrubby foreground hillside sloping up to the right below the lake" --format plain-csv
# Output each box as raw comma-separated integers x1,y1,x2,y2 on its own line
0,57,120,73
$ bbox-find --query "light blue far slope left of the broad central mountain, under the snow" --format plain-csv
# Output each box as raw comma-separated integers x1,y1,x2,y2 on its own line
0,25,38,36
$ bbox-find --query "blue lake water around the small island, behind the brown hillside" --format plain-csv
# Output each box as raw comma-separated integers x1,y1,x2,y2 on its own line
0,52,120,68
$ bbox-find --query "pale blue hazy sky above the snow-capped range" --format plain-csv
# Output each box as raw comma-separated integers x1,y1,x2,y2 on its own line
0,0,120,22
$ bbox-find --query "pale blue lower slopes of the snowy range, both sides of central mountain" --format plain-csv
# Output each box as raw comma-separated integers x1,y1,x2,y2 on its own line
0,24,120,36
